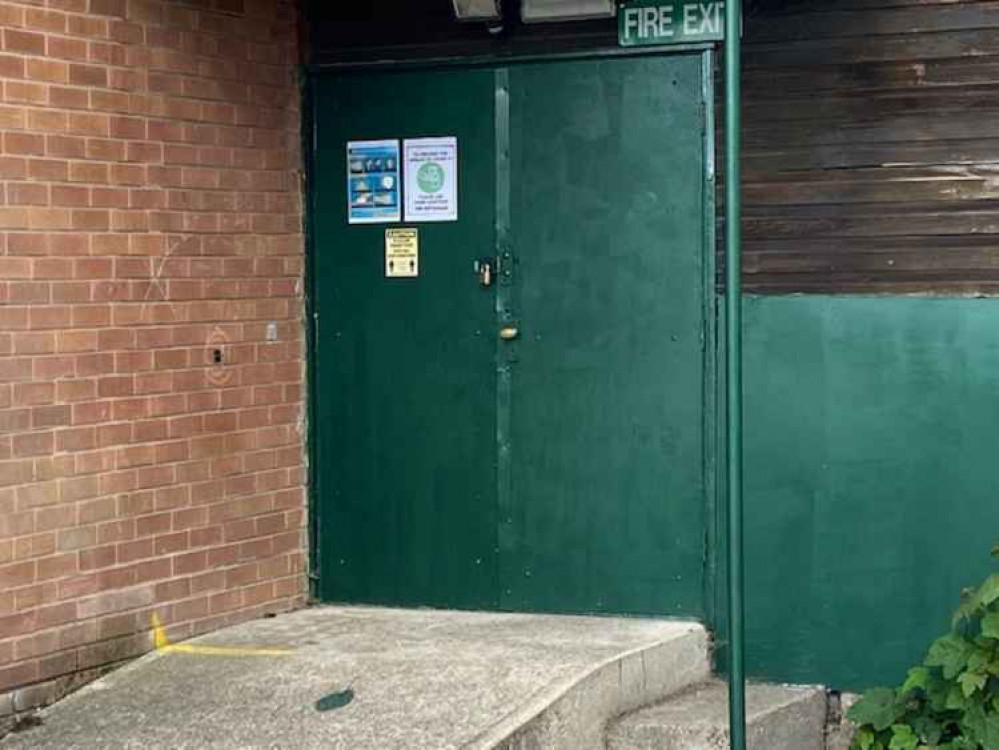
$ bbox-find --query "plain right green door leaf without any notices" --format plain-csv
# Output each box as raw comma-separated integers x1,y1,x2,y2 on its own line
500,55,706,615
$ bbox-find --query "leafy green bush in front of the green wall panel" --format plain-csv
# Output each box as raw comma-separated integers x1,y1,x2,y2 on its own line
847,545,999,750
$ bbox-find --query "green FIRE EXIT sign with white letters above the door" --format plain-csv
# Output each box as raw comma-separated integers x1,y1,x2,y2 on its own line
617,0,725,47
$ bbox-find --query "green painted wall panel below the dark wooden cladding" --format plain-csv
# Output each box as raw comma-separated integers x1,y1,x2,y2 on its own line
745,297,999,689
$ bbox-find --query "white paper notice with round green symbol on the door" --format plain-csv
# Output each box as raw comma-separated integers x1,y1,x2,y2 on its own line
402,138,458,221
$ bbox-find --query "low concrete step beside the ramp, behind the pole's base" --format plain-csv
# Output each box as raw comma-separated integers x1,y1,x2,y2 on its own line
607,681,826,750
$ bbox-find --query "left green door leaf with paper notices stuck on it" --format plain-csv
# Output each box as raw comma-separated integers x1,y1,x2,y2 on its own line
315,70,498,608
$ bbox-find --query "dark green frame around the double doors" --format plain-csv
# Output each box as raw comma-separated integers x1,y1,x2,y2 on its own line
299,44,722,628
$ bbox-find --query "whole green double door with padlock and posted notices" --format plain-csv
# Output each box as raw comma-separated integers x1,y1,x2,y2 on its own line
313,55,710,616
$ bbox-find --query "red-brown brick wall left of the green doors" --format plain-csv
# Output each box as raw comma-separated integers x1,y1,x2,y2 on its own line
0,0,305,716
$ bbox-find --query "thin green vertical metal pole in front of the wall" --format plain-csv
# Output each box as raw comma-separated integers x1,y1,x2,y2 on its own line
725,0,746,750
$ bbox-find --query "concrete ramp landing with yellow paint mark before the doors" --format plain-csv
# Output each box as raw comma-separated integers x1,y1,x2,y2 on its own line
0,607,707,750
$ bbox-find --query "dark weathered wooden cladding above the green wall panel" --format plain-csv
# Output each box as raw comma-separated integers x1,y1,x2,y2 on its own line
736,0,999,294
